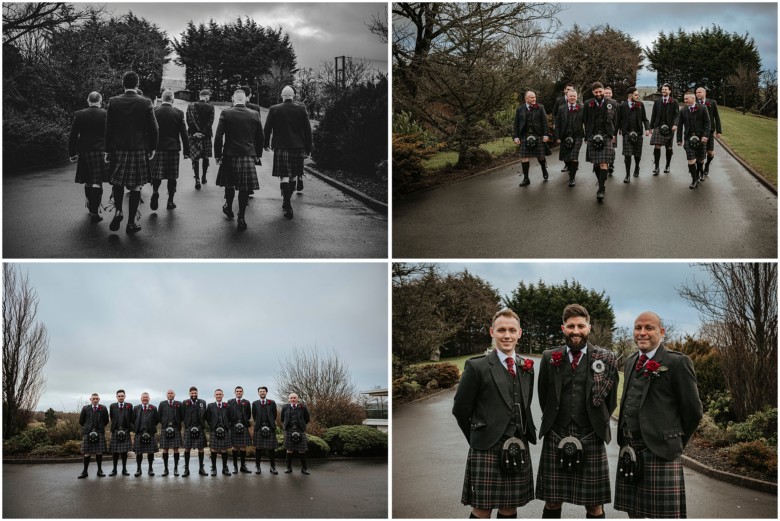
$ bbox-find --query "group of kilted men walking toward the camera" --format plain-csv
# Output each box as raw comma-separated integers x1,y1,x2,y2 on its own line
513,82,722,202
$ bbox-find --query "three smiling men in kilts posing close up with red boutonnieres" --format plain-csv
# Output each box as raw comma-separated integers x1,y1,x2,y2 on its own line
452,304,703,518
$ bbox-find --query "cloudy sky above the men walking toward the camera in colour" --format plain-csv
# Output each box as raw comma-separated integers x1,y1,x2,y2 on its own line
558,2,777,85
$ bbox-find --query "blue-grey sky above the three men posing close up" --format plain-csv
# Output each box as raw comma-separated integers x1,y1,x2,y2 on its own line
432,262,720,334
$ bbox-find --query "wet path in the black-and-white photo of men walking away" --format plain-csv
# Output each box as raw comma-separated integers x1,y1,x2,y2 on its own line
3,100,388,259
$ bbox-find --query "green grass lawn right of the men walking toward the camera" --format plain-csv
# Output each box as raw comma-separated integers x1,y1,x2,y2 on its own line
715,107,777,188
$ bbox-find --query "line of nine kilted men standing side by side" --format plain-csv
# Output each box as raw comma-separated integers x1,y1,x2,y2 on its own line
78,386,310,479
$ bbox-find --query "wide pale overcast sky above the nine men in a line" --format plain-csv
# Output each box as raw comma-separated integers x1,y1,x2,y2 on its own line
10,262,388,411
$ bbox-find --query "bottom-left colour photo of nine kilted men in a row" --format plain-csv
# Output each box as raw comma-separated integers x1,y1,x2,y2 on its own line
2,262,389,519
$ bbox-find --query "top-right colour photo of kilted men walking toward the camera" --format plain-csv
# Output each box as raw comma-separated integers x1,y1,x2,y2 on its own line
391,2,778,259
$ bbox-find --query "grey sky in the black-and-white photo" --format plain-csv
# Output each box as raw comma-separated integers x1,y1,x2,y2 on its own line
105,2,387,79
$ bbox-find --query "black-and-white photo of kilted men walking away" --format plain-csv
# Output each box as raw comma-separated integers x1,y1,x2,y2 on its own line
2,2,389,259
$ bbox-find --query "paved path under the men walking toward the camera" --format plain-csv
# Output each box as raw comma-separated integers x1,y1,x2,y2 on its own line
392,101,777,259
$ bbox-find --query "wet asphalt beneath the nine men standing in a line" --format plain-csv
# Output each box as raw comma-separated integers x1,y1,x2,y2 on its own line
3,454,388,519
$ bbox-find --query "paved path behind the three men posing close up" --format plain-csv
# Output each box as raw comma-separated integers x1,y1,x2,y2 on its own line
392,380,777,519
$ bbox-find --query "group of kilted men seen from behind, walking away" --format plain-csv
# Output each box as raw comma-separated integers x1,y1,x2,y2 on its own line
69,71,312,234
